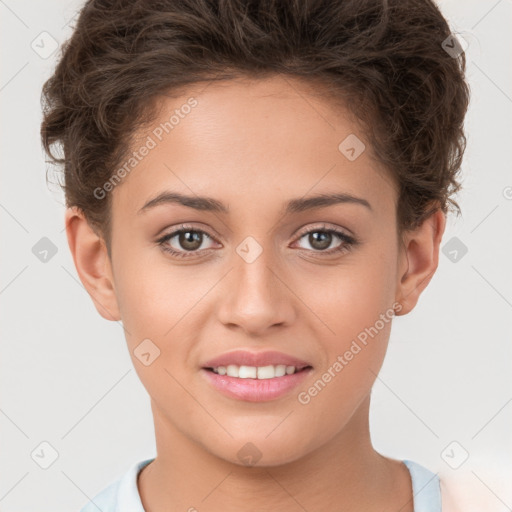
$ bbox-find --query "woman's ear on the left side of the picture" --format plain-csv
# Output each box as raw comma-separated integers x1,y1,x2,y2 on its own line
65,207,121,321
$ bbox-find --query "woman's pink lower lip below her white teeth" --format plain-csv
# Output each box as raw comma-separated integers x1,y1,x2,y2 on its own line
201,368,313,402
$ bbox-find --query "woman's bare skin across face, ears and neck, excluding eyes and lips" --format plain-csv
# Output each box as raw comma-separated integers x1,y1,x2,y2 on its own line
66,77,445,512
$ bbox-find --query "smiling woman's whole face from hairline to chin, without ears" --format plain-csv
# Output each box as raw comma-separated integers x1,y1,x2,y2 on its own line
106,78,406,465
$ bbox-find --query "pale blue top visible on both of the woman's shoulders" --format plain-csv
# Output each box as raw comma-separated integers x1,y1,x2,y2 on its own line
80,459,441,512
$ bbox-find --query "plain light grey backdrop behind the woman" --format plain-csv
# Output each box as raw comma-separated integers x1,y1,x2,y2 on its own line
0,0,512,512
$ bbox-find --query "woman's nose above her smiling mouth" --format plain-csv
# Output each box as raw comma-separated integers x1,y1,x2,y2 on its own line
218,251,296,336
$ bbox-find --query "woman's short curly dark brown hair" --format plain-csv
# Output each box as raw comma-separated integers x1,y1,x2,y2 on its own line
41,0,469,246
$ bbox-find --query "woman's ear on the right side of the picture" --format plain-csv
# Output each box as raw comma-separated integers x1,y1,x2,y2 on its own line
395,209,446,316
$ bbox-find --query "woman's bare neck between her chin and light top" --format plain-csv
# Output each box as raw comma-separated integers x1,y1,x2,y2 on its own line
138,396,412,512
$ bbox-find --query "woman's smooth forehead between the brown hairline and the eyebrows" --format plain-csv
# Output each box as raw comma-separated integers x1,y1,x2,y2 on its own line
114,77,396,218
